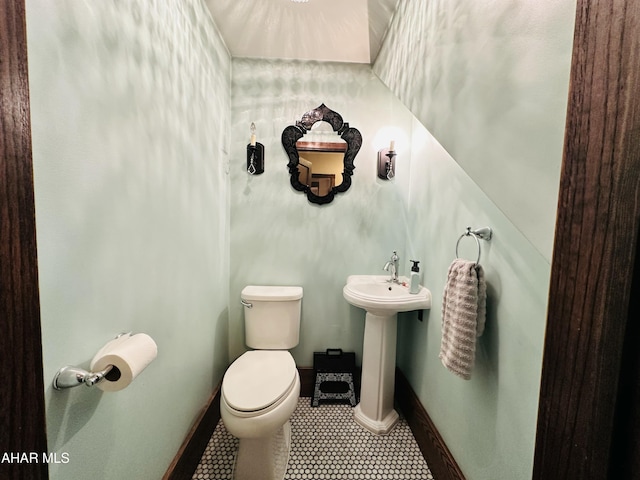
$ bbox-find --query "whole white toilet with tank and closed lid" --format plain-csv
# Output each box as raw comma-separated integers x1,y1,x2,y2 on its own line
220,285,302,480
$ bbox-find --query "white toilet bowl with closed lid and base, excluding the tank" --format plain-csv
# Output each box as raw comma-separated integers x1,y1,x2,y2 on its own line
220,350,300,480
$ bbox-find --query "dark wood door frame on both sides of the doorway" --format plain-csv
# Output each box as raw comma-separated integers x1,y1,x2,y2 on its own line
8,0,640,479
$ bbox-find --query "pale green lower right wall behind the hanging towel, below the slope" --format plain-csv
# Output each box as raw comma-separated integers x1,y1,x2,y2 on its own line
397,120,550,480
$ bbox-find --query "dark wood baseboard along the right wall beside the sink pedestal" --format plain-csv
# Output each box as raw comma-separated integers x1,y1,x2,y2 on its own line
395,368,465,480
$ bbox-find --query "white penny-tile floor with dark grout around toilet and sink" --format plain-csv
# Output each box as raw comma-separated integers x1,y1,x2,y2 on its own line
193,397,433,480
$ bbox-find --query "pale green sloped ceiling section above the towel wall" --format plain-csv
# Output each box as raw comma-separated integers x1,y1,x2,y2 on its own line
374,0,576,261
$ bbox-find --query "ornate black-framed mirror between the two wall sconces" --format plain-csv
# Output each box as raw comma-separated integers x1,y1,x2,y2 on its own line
282,104,362,204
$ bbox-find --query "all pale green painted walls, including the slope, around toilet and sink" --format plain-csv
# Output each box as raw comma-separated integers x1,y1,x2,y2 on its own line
27,0,575,480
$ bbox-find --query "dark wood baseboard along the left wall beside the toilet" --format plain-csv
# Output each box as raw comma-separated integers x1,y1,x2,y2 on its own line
162,385,220,480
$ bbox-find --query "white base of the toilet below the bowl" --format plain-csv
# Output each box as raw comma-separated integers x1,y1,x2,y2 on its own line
233,421,291,480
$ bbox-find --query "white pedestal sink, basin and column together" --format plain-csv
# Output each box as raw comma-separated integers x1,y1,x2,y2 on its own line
342,275,431,435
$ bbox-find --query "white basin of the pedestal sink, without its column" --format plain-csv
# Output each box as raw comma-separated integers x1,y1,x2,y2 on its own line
342,275,431,316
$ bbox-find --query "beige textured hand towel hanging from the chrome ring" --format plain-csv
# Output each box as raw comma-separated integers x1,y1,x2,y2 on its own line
439,259,487,380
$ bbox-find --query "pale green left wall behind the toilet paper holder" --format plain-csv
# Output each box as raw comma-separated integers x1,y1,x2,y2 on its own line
27,0,231,480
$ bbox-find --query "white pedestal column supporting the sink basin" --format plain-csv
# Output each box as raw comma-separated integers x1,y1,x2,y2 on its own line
354,312,398,435
